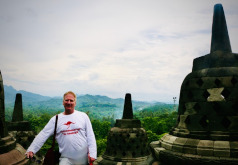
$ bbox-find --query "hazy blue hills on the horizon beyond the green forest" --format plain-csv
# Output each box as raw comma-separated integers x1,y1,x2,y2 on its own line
4,85,171,118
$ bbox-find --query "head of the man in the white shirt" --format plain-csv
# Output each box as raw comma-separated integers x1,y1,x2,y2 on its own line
63,91,77,115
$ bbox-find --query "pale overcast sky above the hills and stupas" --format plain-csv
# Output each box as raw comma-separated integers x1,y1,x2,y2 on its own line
0,0,238,102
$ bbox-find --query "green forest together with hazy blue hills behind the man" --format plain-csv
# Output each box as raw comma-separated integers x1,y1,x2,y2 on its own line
5,89,177,156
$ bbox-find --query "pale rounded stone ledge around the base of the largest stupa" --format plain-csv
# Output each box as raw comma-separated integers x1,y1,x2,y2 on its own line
154,135,238,158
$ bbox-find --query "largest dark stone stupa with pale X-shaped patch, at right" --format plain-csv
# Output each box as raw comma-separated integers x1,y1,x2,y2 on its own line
151,4,238,165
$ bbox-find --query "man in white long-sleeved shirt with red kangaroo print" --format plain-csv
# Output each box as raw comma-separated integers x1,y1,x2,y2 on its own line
26,91,97,165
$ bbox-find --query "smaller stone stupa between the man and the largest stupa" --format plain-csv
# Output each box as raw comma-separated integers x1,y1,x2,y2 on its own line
98,94,149,165
